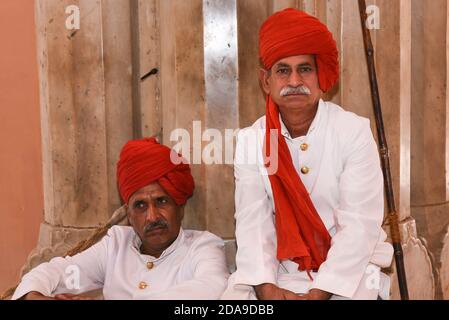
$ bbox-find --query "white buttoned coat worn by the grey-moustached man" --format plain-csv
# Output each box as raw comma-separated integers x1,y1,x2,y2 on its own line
222,100,393,299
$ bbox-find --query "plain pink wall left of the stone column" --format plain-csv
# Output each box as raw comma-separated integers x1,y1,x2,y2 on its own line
0,0,43,292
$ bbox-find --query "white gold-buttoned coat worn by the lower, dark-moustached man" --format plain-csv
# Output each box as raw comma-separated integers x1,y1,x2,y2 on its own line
13,226,229,300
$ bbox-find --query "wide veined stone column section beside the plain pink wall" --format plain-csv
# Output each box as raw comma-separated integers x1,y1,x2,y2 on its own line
24,0,133,271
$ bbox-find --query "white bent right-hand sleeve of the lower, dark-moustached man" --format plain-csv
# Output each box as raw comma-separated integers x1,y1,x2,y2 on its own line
148,234,229,300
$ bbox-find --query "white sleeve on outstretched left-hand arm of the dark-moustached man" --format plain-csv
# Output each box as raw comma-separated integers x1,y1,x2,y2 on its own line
12,228,110,300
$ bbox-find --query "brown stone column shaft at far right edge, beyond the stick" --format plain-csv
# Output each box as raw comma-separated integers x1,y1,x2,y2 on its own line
412,0,446,205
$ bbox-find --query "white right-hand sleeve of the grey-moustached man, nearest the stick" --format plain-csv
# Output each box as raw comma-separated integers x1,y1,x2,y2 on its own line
312,120,384,298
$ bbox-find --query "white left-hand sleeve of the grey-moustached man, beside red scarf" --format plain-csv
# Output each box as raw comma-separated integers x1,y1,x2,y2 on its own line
234,128,279,286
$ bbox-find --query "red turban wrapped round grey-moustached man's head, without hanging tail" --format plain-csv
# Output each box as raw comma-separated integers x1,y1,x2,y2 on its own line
259,8,339,92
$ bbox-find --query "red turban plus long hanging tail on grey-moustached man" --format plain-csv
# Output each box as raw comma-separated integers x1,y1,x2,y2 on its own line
259,9,339,277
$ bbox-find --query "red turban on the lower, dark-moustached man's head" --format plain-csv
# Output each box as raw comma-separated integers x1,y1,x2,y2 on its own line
117,138,195,205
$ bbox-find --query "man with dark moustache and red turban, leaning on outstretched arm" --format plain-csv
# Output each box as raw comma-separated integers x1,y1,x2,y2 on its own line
13,138,228,300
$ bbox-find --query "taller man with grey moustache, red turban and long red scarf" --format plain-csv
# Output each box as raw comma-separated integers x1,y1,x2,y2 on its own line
223,9,393,300
